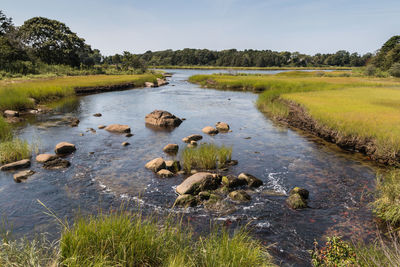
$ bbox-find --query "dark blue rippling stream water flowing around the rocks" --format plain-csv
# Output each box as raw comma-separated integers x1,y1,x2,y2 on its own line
0,70,375,266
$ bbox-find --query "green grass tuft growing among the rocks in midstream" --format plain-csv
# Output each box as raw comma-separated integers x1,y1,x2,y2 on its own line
182,143,232,173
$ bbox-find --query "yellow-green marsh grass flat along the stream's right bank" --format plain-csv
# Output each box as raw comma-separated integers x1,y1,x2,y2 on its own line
190,71,400,165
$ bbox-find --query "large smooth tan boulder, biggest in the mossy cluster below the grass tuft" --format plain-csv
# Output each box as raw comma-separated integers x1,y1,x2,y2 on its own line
176,172,221,195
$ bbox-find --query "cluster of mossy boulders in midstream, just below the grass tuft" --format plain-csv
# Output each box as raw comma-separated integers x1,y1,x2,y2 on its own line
174,172,263,207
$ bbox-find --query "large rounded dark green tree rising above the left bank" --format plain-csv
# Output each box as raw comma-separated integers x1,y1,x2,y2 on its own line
19,17,87,66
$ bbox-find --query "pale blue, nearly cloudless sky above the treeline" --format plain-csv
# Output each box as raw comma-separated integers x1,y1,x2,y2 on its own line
0,0,400,55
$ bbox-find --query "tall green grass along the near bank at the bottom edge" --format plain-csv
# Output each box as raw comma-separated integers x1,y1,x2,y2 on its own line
0,212,272,267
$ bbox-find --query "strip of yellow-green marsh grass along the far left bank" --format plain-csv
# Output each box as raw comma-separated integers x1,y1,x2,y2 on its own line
0,74,157,110
